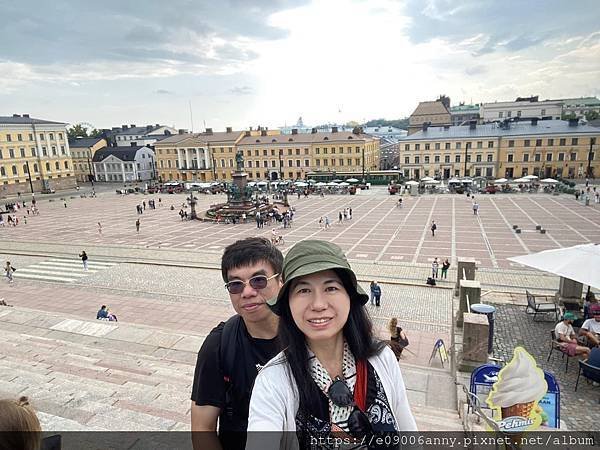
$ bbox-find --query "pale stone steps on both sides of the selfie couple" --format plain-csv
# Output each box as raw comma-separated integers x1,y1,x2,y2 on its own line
0,307,463,431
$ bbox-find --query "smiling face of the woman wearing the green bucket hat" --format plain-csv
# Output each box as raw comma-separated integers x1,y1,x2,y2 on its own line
289,270,350,343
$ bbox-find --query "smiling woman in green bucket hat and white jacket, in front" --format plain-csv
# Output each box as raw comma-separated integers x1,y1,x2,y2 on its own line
247,240,416,449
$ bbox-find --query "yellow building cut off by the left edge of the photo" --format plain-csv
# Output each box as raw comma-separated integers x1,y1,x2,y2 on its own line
0,114,77,196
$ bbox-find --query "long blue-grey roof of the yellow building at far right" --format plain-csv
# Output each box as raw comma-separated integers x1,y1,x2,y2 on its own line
401,120,600,140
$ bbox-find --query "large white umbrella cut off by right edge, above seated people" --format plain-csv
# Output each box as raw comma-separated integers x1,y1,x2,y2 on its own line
507,244,600,289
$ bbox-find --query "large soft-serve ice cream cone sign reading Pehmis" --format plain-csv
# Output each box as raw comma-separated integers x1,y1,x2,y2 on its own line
486,347,548,433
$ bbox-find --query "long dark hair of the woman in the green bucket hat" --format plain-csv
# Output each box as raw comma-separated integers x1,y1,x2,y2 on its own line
278,270,385,407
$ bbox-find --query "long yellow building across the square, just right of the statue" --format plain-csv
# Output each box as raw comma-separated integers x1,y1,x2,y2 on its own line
236,127,379,180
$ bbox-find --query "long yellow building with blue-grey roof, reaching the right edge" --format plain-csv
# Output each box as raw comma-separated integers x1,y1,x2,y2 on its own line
400,119,600,179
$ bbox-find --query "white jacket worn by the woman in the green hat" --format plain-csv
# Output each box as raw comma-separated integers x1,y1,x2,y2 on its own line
246,346,417,450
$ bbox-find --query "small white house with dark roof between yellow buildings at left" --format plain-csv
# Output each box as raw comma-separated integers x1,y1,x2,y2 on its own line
92,145,156,182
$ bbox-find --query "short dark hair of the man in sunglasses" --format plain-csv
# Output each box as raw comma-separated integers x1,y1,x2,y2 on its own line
221,237,283,283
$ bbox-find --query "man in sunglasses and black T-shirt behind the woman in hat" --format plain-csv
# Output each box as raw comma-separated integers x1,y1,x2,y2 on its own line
191,237,283,450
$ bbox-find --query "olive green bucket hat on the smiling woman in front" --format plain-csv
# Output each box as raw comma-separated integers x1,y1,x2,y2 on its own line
267,240,369,315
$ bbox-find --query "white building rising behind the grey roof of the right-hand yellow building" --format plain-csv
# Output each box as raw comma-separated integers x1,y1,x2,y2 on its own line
479,96,563,123
